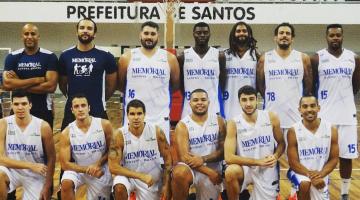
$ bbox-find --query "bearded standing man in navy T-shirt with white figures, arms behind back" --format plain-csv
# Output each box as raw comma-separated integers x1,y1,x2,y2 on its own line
59,18,117,130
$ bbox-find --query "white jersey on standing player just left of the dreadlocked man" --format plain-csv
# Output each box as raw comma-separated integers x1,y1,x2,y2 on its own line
181,47,221,118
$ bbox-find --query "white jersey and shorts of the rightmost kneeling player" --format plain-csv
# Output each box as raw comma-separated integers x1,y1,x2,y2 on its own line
288,120,331,200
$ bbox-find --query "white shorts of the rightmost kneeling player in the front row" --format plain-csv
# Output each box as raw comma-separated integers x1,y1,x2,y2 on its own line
288,170,330,200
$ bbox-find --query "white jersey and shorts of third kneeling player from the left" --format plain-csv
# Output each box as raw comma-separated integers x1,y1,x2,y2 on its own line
114,123,162,200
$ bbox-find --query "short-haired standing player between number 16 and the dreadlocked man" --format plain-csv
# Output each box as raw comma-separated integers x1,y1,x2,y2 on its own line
178,22,226,118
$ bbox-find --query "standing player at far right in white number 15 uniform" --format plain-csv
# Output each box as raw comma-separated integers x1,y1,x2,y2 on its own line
311,24,360,200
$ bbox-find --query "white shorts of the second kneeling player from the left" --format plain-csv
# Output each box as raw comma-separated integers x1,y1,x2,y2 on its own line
61,165,112,200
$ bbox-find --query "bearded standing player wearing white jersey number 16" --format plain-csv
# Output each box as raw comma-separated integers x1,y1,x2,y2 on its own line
118,21,179,142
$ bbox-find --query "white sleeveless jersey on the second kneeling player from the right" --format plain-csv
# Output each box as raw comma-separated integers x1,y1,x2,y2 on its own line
234,110,279,180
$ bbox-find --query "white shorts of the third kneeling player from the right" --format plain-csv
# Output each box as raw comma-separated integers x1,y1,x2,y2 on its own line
178,162,223,200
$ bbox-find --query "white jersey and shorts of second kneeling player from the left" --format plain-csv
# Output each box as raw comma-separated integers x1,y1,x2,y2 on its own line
61,117,112,200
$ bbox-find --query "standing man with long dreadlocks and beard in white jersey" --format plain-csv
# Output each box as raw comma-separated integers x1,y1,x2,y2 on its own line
223,22,260,120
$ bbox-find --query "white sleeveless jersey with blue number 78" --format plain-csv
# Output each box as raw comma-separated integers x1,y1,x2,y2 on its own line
264,50,304,128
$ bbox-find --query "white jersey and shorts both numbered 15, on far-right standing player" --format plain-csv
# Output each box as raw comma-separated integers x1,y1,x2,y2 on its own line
317,49,358,159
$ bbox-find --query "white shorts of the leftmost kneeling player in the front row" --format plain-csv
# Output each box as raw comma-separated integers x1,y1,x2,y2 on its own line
0,166,45,199
